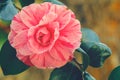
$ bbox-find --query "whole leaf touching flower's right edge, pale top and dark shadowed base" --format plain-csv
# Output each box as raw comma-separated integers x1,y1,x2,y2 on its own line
80,28,100,52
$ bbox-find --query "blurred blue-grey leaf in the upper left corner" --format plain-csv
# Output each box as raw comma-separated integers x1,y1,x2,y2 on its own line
0,0,18,27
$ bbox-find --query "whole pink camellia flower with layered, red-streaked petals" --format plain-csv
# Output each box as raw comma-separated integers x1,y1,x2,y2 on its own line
8,2,81,68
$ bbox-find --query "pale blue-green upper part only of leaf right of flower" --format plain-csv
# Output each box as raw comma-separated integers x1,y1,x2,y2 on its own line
81,28,100,42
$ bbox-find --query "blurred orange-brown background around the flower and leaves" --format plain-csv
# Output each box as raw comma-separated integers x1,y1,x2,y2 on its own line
0,0,120,80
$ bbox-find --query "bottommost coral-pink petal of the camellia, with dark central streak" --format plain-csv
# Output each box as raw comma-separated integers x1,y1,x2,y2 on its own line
30,52,67,69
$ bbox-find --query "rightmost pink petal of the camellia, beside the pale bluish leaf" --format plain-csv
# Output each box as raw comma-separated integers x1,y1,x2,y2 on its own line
59,18,82,48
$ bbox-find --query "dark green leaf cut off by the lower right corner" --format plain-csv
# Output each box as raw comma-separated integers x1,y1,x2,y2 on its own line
108,66,120,80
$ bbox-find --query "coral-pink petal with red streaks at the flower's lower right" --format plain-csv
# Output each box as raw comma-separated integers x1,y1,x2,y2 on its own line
50,41,73,61
